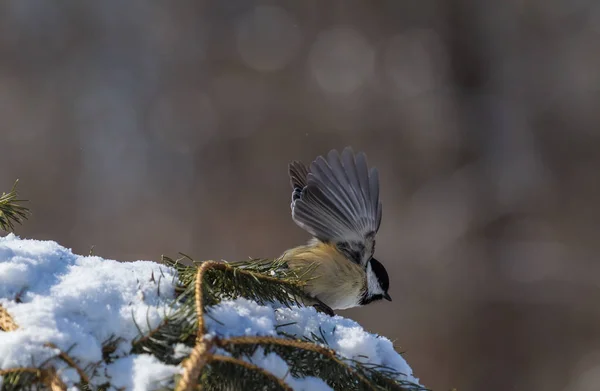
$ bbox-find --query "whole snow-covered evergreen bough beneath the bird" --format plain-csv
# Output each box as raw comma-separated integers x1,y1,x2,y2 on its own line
0,234,424,391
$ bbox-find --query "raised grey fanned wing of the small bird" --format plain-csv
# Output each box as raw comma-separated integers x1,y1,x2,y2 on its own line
289,147,381,266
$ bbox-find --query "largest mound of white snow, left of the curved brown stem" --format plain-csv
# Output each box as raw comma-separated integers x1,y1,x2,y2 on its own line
0,234,179,390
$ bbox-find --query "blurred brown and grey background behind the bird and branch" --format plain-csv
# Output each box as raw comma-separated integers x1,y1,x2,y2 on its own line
0,0,600,391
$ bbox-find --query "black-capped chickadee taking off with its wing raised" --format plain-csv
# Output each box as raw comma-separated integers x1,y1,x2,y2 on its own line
282,147,392,314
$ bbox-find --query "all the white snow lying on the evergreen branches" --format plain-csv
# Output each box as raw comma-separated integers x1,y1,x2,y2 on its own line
0,234,418,391
